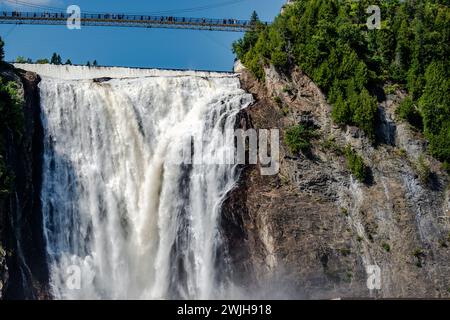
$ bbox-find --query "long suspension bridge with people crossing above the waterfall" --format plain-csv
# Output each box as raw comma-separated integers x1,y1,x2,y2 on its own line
0,11,268,32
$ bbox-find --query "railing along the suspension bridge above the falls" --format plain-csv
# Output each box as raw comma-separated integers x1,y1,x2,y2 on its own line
0,11,267,29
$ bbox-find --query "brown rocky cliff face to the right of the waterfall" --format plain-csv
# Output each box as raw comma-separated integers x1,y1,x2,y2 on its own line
222,63,450,298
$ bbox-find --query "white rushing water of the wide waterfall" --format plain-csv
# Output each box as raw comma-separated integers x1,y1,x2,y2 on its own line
28,66,252,299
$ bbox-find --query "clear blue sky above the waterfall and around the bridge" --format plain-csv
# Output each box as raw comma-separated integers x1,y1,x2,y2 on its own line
0,0,285,71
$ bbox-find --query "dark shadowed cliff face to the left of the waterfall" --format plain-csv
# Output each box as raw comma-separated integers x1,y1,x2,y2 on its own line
0,68,48,299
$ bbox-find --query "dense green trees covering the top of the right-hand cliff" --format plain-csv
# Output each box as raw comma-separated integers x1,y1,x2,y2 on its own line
233,0,450,168
